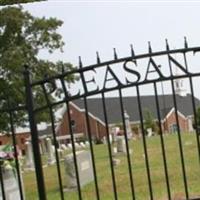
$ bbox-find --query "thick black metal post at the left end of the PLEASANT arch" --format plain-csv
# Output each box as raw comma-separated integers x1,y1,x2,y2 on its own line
24,66,46,200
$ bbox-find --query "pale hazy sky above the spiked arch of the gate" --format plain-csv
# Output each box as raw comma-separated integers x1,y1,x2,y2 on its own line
21,0,200,97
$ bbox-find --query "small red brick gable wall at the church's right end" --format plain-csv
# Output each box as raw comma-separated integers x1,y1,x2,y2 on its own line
163,111,188,132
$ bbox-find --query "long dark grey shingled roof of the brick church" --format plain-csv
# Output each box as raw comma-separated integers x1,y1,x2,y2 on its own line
73,94,200,124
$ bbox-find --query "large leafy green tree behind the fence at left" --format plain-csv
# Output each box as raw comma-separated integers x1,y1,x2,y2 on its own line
0,6,76,131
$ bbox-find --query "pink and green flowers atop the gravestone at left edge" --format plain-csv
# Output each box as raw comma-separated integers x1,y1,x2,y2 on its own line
0,144,15,170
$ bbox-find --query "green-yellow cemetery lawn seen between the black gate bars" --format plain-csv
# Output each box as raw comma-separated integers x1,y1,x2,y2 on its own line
23,133,200,200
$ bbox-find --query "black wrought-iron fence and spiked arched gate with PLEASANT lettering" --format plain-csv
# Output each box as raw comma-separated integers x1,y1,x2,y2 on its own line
0,38,200,200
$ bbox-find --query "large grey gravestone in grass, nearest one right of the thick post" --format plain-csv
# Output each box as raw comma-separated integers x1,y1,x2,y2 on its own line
65,151,94,188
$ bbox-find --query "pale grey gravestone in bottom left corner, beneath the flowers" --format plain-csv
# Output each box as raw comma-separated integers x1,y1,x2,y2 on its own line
0,169,22,200
